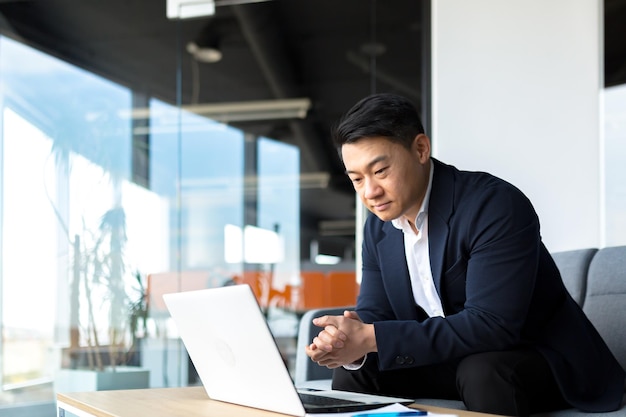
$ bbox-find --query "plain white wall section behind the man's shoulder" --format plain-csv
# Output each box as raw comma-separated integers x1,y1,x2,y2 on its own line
430,0,603,251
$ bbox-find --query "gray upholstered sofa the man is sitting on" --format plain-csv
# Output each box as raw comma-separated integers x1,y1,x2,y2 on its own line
294,246,626,417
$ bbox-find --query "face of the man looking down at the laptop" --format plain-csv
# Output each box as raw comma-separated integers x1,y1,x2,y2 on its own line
341,134,430,222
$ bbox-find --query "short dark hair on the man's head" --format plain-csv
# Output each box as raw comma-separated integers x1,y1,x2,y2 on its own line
331,94,424,155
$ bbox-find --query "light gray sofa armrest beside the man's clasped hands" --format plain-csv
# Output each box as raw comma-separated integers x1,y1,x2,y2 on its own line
294,307,354,389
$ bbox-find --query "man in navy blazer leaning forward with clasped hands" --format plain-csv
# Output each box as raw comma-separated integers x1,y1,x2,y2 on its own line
306,94,624,416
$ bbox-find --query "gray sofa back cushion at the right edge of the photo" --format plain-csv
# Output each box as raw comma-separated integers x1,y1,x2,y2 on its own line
583,246,626,369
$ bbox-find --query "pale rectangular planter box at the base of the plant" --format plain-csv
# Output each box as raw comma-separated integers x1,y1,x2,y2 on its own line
54,366,150,392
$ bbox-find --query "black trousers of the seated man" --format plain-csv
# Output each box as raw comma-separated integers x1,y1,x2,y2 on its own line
333,349,569,416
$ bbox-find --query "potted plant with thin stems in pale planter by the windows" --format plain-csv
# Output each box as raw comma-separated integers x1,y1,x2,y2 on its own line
56,201,149,391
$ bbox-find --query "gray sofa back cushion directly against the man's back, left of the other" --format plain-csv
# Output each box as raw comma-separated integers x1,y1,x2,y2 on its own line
552,248,598,307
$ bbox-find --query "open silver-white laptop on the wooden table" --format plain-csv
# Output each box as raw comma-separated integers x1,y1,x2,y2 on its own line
163,284,413,417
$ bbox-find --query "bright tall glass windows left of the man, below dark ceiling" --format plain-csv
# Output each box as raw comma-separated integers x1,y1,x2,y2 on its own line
0,26,300,405
